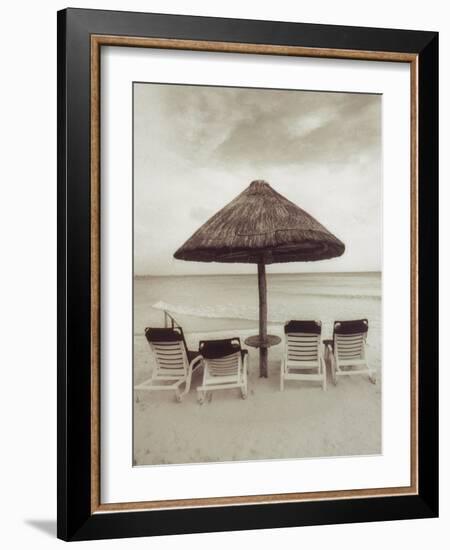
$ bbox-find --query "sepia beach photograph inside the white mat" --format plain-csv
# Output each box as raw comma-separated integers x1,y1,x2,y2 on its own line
133,82,383,466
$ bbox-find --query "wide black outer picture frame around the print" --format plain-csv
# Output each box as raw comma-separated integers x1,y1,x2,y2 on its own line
57,9,438,540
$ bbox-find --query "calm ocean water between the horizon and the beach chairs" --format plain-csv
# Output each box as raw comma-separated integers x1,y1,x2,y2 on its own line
134,272,381,351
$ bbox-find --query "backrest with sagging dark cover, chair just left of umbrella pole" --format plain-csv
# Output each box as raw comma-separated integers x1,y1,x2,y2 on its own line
198,338,241,376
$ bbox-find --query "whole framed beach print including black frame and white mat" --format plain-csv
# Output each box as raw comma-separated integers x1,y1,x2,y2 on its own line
58,9,438,540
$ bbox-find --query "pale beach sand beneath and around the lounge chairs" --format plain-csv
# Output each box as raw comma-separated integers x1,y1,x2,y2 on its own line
134,327,381,465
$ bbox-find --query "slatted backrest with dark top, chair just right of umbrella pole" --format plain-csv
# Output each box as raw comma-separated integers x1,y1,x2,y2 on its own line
284,321,322,363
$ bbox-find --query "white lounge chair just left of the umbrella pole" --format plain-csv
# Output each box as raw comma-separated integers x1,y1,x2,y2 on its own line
197,338,248,404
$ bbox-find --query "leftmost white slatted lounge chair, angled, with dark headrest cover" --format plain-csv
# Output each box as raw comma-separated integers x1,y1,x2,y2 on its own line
134,327,202,402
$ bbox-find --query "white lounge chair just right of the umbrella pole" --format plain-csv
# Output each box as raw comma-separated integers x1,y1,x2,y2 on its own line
280,321,327,391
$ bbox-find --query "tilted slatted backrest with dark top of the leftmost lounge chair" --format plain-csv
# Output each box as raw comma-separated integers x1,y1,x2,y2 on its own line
145,327,188,376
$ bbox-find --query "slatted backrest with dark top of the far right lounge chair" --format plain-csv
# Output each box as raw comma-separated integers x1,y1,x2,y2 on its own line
333,319,369,361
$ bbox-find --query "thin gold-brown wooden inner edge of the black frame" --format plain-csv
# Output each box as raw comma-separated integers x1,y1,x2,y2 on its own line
90,34,419,514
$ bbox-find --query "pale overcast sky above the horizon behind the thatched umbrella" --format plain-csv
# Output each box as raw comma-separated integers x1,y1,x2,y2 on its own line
134,84,382,275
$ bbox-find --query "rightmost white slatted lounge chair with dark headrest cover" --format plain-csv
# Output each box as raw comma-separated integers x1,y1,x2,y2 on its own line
328,319,376,384
